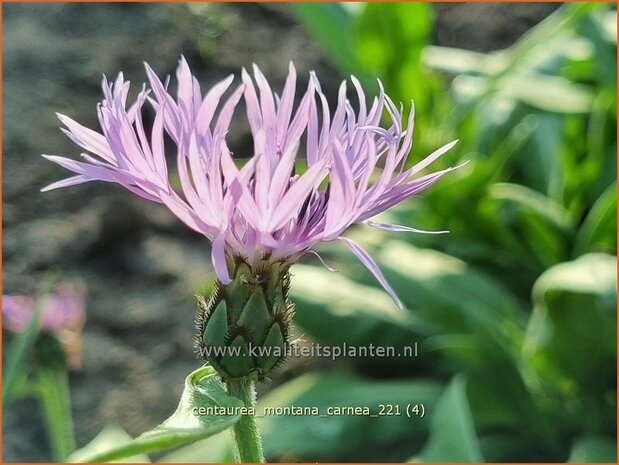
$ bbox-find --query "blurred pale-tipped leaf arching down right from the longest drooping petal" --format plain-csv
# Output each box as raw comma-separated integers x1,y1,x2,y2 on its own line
358,240,552,441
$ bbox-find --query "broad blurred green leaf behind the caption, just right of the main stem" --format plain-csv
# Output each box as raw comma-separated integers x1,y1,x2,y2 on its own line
257,373,441,461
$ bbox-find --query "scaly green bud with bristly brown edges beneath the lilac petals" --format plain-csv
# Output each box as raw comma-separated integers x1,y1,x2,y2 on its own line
196,258,294,380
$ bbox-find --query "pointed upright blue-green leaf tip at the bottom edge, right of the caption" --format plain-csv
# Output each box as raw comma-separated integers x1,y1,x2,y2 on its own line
413,377,484,462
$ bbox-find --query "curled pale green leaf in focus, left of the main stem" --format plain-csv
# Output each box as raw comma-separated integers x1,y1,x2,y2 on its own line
71,366,243,462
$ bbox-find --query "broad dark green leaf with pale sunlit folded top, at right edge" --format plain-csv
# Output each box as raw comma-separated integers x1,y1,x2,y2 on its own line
523,254,617,429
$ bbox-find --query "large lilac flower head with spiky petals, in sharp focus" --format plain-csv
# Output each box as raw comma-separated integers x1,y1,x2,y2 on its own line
43,58,455,305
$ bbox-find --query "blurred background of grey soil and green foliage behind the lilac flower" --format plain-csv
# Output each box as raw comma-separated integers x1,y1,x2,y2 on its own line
2,3,617,462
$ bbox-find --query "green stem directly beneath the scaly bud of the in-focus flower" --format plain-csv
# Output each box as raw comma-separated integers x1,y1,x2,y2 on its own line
226,378,264,463
